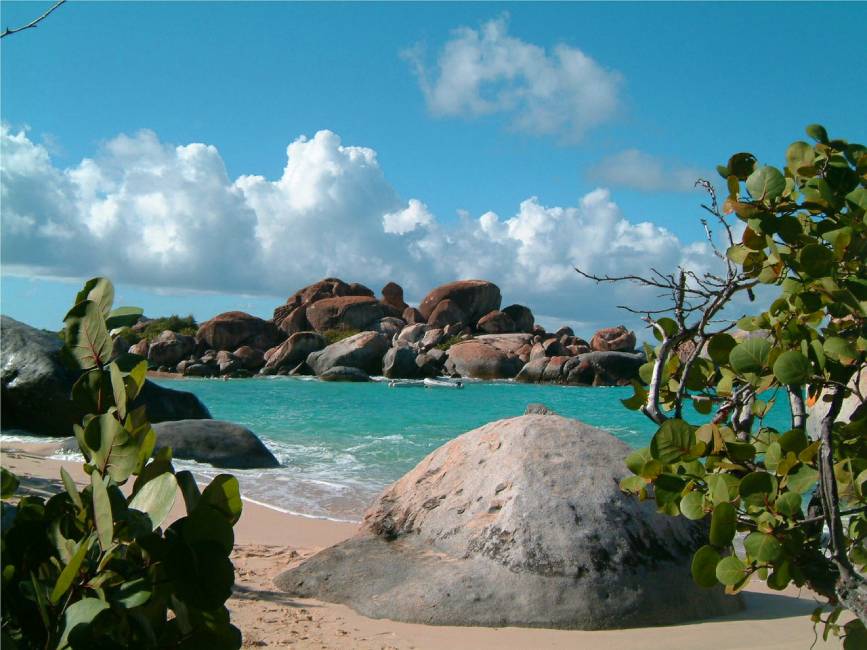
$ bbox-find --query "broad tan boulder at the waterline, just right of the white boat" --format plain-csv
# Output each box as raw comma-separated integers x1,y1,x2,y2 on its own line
445,334,530,379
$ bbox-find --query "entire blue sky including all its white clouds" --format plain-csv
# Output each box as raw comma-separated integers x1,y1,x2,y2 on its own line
0,0,867,336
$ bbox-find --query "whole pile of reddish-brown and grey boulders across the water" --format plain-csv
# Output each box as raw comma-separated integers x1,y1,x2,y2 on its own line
137,278,644,385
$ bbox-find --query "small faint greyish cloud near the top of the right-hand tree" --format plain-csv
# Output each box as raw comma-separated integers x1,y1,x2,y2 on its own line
589,149,707,192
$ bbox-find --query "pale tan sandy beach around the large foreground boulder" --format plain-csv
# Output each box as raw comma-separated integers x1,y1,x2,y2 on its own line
2,442,839,650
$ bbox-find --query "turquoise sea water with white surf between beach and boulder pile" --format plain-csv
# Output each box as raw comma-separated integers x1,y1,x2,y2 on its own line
158,377,788,520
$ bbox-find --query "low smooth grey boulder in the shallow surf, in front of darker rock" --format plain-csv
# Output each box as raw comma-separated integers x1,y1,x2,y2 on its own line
154,420,280,469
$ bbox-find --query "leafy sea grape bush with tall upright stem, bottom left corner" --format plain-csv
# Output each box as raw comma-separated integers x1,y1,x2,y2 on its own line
2,278,241,650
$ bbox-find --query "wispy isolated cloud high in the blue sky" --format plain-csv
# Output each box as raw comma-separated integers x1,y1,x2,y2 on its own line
405,17,621,141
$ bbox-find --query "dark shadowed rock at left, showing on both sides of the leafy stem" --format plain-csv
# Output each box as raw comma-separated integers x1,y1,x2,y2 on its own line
0,316,211,436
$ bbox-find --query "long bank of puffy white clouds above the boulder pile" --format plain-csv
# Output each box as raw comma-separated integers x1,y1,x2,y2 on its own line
0,125,712,332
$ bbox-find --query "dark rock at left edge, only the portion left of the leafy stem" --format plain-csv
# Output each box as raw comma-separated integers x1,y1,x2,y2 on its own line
0,316,78,436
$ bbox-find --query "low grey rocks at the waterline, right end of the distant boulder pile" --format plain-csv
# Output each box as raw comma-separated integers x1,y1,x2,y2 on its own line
515,352,646,386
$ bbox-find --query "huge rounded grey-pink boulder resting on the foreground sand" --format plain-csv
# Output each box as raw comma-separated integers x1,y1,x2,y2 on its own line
276,415,741,629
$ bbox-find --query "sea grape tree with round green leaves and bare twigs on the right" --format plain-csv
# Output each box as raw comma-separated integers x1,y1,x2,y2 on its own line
612,125,867,636
